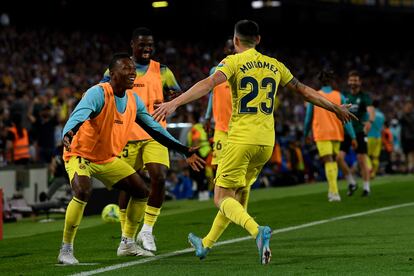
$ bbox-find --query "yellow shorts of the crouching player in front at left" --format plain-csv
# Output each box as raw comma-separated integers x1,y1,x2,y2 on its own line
65,156,135,190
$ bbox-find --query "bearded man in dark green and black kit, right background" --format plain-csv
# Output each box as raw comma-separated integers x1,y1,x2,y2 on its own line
337,71,375,196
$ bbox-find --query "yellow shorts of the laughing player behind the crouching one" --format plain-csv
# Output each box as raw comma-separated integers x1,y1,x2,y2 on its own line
118,139,170,170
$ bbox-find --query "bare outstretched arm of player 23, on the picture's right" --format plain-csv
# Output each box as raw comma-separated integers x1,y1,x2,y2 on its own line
286,78,358,122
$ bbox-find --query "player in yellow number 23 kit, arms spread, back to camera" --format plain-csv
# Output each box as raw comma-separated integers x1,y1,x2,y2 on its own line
153,20,353,264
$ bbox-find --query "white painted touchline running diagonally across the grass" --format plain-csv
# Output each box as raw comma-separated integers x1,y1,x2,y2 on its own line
72,202,414,276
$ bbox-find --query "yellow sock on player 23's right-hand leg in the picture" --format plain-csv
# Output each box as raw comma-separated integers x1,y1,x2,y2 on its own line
220,197,259,238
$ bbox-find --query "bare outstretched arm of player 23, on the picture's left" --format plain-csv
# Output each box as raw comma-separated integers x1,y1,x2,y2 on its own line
152,71,227,121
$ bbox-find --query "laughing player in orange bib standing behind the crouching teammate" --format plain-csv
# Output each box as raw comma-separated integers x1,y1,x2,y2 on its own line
102,27,181,252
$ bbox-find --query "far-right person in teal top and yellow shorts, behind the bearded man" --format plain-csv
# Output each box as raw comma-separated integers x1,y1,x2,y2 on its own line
367,100,385,178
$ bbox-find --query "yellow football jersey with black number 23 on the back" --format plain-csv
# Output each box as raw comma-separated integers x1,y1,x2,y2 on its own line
216,48,293,146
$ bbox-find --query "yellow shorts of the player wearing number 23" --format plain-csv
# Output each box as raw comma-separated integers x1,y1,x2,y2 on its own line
214,144,273,189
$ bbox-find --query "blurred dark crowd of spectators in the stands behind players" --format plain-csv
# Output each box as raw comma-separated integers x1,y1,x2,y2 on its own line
0,27,414,197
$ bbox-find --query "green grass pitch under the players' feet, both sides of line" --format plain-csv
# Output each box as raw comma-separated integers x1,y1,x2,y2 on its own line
0,176,414,275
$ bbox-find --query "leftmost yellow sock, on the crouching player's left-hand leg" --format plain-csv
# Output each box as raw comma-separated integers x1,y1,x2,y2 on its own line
63,197,86,244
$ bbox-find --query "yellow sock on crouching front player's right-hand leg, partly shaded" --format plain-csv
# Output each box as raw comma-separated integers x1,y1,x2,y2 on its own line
122,197,148,239
